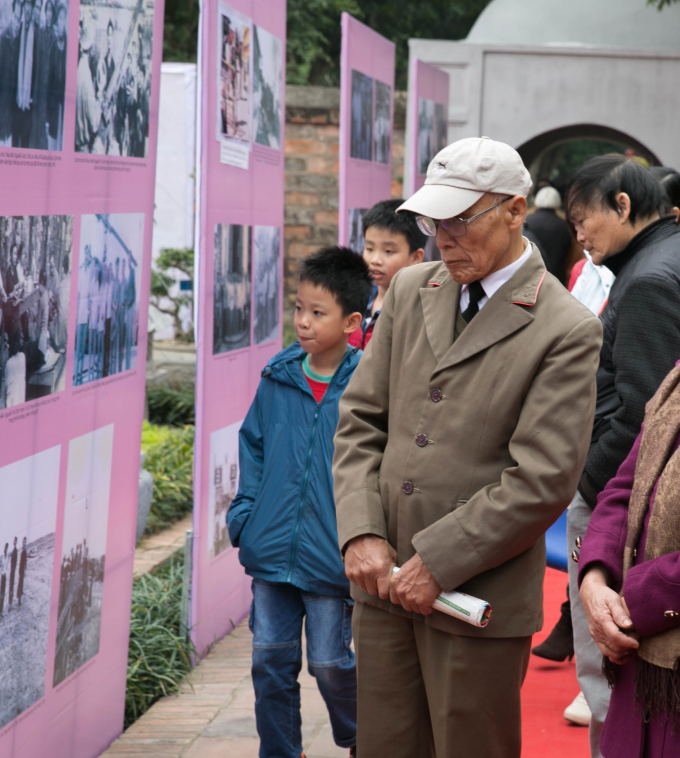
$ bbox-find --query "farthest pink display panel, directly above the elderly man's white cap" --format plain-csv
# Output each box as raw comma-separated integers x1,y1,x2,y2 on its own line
404,58,449,197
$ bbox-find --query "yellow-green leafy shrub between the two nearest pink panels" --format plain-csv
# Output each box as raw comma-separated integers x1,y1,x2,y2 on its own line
142,423,194,534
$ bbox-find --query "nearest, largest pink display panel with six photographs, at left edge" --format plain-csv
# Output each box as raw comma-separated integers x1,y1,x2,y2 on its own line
0,0,163,758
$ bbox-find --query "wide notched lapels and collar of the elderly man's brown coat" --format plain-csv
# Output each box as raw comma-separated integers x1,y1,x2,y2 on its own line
420,244,546,373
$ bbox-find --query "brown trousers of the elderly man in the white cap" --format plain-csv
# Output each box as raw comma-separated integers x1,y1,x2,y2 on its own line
352,603,531,758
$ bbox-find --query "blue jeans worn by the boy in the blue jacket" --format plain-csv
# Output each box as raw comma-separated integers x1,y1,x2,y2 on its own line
248,579,357,758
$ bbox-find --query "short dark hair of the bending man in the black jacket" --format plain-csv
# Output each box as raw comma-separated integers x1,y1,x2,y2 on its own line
566,153,670,224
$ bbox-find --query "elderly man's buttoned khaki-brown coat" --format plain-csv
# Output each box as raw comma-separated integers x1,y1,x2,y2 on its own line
333,247,602,637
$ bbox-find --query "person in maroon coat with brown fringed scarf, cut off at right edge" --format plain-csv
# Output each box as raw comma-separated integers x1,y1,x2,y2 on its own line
579,362,680,758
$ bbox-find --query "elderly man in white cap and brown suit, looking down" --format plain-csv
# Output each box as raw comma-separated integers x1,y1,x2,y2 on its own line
333,137,602,758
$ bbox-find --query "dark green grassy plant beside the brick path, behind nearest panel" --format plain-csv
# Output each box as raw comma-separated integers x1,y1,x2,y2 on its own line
125,554,195,728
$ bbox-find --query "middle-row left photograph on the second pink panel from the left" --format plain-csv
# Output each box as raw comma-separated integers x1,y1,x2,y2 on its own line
213,224,252,355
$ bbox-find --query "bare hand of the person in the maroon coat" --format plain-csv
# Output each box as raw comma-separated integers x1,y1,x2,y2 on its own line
580,568,640,665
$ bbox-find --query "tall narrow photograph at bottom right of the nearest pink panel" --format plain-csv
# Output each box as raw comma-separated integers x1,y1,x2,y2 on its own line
54,424,113,687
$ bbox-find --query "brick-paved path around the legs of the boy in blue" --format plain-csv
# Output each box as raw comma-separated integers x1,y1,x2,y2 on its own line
103,622,349,758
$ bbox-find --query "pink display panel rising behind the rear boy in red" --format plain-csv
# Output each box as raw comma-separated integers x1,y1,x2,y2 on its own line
338,13,396,253
